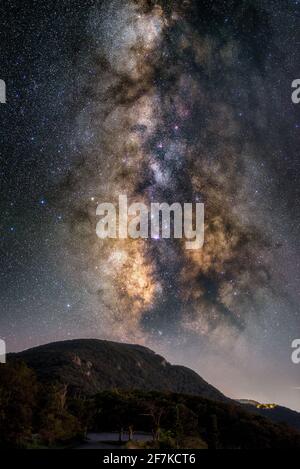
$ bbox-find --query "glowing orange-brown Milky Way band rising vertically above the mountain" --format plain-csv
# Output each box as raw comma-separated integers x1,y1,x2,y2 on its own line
58,2,272,340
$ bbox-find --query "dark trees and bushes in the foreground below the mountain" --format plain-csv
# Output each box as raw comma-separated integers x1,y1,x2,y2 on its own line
0,362,300,449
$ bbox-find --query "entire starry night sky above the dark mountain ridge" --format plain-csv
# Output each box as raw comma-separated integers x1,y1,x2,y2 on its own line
0,0,300,410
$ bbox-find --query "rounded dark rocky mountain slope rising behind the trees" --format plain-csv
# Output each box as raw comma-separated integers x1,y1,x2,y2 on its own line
8,339,228,401
